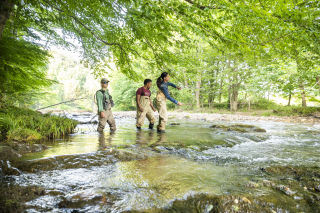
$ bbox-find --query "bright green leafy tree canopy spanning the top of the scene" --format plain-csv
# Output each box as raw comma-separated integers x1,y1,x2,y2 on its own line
0,0,320,110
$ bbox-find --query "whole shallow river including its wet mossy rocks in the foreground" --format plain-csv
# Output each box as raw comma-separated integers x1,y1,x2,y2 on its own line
0,112,320,212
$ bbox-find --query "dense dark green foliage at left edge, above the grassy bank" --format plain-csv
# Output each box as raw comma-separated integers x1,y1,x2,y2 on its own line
0,37,52,106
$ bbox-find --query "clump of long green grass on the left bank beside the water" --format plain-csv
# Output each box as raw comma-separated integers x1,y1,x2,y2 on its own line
0,107,78,141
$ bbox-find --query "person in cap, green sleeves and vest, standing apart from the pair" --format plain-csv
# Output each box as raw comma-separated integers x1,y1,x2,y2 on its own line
96,78,116,133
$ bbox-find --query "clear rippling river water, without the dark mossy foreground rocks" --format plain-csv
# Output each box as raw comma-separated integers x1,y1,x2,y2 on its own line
5,115,320,212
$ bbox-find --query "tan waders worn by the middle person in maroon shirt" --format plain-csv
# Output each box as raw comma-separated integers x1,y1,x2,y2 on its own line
136,96,155,129
